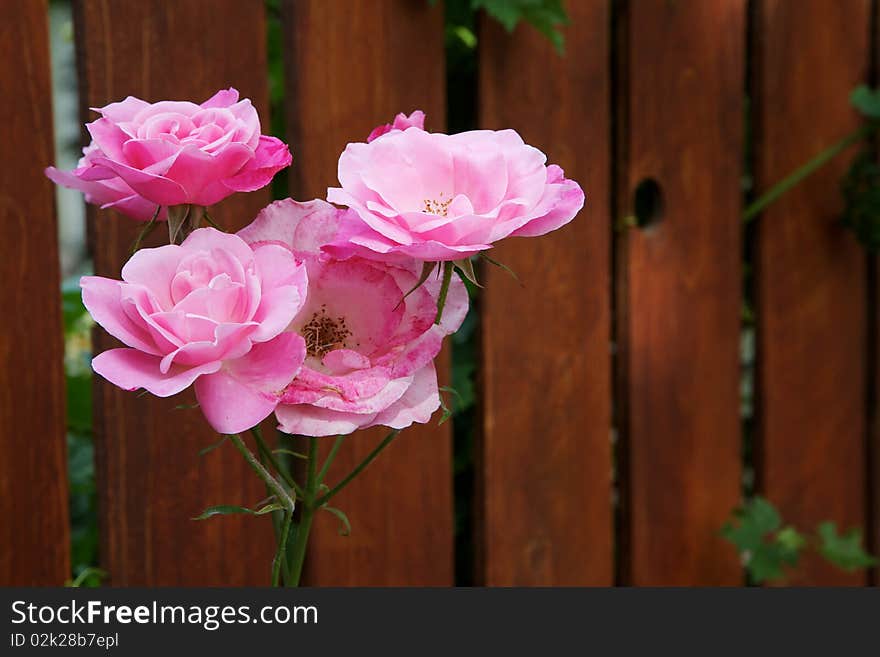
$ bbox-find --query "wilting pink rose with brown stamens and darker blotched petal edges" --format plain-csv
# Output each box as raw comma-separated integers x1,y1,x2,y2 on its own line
239,199,468,436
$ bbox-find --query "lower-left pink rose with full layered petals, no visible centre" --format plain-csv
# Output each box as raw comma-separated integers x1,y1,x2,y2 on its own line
81,228,308,433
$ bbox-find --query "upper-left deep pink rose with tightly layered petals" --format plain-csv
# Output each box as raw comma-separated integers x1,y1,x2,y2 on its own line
46,89,291,220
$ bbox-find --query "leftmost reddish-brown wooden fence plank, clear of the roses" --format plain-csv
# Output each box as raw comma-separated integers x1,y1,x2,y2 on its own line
0,0,70,586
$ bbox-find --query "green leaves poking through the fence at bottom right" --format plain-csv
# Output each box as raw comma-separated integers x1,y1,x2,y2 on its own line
721,496,876,584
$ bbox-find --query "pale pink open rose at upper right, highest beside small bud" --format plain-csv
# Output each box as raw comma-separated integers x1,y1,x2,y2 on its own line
327,115,584,261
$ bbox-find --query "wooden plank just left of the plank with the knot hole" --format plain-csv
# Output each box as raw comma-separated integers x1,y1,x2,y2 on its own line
477,0,614,586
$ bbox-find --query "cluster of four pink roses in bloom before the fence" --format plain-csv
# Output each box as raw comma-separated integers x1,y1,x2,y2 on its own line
47,89,584,436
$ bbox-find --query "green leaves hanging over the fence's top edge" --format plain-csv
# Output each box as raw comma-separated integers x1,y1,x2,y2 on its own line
428,0,568,55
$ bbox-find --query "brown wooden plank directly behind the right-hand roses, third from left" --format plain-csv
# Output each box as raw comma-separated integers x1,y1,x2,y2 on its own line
283,0,453,585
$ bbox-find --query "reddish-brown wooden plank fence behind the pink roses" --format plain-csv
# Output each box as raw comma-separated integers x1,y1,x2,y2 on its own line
0,0,880,586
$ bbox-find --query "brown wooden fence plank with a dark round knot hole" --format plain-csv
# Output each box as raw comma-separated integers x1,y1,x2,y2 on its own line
617,0,746,585
